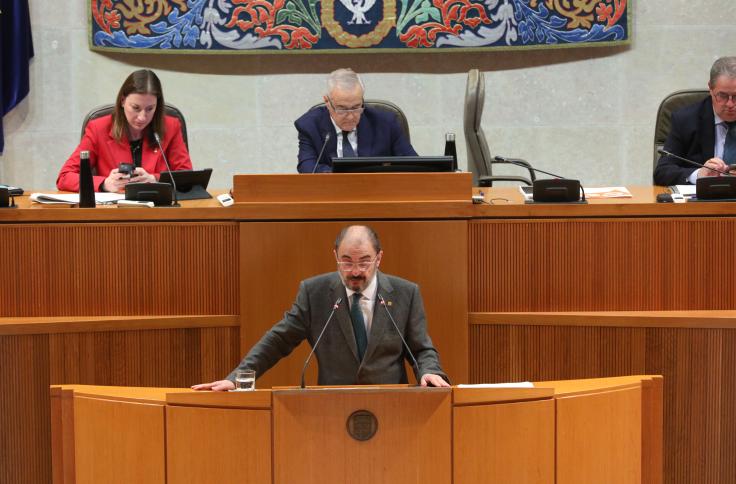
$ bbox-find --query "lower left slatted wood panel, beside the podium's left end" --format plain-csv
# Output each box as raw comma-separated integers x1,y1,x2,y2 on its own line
0,327,240,484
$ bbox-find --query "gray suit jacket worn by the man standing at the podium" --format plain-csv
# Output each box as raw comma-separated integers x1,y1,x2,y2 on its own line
227,272,449,385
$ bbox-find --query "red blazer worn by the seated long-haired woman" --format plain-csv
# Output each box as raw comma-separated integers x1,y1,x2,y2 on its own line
56,114,192,192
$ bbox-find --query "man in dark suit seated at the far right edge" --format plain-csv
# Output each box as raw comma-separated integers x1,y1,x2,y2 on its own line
654,57,736,185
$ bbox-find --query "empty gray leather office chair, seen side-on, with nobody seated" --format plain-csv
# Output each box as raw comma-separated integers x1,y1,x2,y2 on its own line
463,69,536,187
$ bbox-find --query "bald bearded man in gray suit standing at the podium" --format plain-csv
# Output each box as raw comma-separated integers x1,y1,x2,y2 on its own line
192,225,449,391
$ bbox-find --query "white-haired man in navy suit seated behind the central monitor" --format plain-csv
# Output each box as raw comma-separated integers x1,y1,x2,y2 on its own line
294,69,417,173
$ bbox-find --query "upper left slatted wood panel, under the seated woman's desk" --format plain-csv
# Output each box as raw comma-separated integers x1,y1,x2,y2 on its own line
0,223,239,317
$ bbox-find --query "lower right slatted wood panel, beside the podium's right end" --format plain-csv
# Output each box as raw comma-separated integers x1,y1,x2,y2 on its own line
469,325,736,484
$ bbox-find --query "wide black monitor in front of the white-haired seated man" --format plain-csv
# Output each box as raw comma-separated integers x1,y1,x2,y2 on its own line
332,156,454,173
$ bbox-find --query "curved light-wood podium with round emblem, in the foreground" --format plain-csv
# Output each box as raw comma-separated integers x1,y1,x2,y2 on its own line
51,376,662,484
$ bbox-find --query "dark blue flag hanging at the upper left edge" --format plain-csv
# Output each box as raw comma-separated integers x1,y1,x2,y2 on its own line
0,0,33,153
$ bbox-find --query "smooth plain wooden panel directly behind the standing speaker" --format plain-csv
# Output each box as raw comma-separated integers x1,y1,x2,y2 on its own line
240,220,468,388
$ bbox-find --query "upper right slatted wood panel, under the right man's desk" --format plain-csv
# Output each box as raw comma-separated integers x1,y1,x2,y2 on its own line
468,218,736,312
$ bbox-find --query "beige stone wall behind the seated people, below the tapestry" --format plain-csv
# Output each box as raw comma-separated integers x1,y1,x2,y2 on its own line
0,0,736,189
